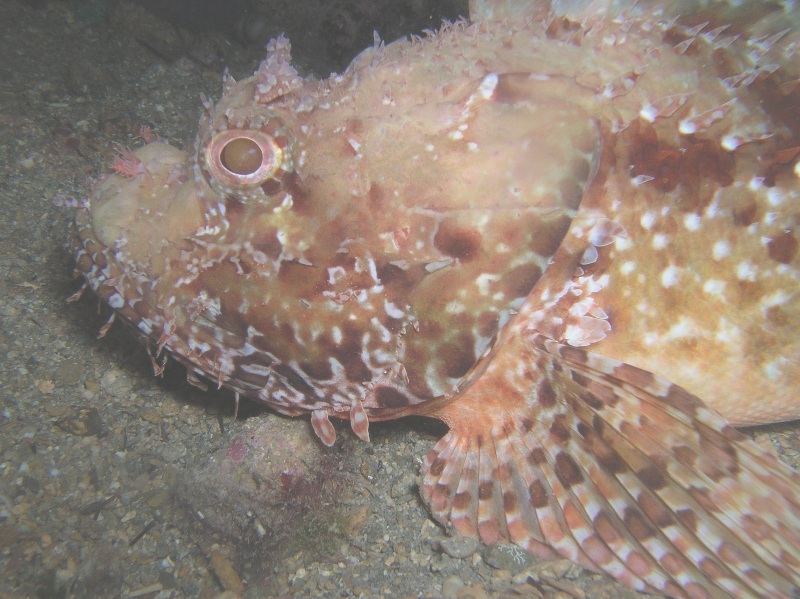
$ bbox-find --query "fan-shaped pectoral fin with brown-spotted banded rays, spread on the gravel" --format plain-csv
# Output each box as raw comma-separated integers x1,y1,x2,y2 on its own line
422,334,800,598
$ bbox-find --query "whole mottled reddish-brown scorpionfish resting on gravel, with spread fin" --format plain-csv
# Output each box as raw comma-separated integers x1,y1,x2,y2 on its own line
74,0,800,598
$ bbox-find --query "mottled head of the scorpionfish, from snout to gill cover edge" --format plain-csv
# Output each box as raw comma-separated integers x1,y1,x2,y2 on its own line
78,38,601,417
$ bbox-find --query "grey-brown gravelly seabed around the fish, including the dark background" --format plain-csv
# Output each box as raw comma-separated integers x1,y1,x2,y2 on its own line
0,0,800,599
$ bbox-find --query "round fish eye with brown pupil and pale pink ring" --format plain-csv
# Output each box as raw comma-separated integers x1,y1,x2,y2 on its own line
206,129,283,187
